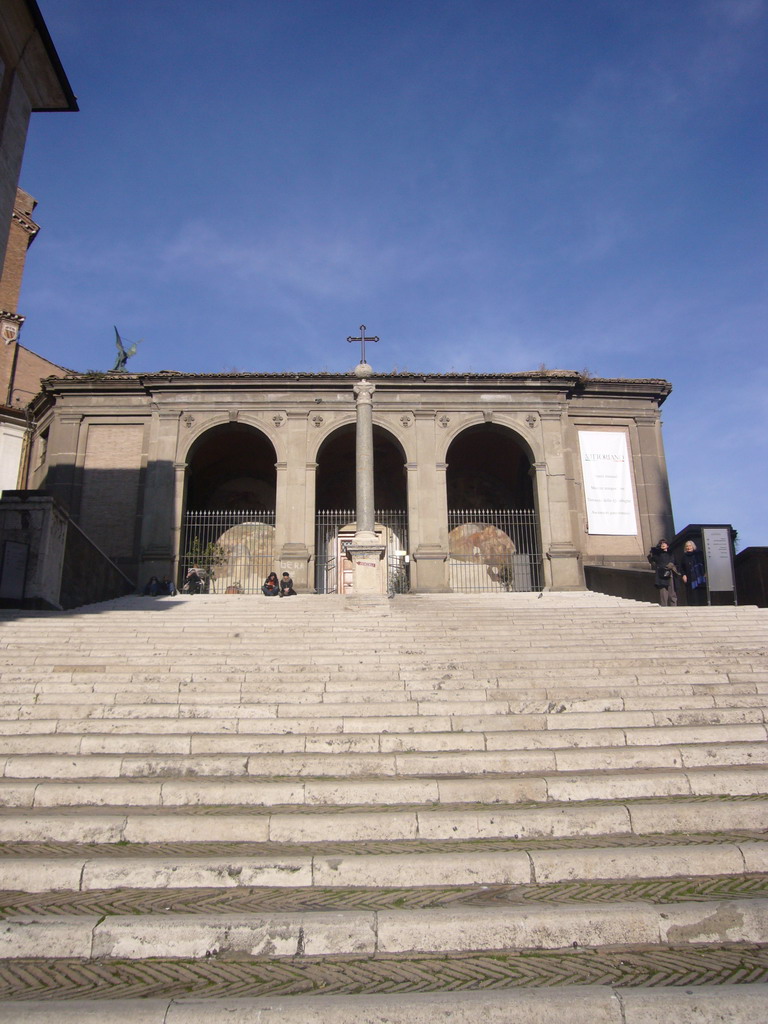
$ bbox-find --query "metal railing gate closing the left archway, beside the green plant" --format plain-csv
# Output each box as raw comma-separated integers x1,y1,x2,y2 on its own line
178,509,274,594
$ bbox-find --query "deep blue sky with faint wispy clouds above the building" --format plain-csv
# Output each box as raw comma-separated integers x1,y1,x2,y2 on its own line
19,0,768,547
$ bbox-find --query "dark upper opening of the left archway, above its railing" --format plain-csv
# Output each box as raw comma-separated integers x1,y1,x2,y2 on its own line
184,422,276,512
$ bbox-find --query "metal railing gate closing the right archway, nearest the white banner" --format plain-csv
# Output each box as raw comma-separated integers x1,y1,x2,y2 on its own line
449,509,543,594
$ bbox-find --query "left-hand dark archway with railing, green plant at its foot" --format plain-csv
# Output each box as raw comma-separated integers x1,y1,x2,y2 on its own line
179,423,276,594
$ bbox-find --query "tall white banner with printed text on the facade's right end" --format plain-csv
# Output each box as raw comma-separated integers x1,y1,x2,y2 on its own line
579,430,637,537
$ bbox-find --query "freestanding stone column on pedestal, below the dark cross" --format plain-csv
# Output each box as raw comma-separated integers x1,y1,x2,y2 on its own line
347,362,384,594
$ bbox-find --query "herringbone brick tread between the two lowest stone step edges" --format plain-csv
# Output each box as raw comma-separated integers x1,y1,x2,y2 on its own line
0,944,768,1000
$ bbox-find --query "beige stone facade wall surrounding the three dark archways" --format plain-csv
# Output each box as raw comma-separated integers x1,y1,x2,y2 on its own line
28,371,672,592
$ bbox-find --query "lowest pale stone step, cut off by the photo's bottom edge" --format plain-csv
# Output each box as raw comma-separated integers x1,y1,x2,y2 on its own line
6,987,768,1024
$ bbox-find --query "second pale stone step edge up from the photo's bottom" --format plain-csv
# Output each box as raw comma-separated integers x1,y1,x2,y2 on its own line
6,898,768,959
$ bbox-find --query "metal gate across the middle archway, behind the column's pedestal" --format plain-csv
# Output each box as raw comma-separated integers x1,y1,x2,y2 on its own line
314,509,409,594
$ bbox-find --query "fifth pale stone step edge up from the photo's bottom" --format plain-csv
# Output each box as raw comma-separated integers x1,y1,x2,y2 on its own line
0,765,768,808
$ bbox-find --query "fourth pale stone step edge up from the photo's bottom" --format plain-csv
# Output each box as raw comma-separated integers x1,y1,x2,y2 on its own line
0,798,768,844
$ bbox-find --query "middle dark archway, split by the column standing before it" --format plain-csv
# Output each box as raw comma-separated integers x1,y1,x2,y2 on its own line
314,423,409,594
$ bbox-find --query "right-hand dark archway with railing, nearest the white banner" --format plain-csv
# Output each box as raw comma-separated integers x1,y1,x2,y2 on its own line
445,423,543,592
